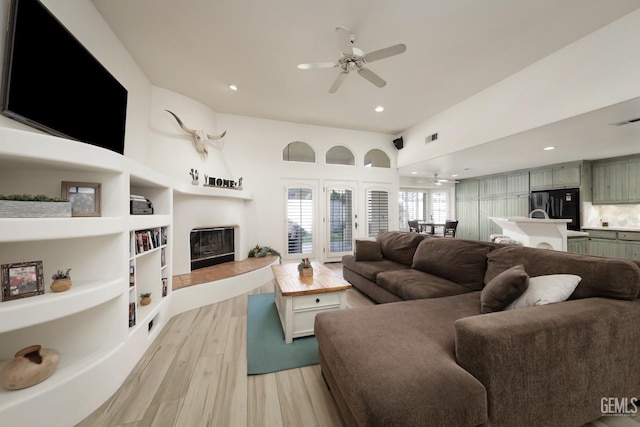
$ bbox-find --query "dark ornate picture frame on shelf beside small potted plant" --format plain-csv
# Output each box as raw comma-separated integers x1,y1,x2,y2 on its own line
0,261,44,301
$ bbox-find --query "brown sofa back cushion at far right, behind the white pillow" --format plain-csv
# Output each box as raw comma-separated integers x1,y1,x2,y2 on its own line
484,246,640,300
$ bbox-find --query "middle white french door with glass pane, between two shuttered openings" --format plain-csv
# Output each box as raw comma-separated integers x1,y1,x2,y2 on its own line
325,184,357,261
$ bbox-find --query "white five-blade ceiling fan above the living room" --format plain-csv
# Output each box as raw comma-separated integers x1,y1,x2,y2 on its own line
298,27,407,93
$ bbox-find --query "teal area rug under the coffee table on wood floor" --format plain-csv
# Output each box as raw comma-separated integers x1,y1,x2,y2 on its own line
247,293,319,375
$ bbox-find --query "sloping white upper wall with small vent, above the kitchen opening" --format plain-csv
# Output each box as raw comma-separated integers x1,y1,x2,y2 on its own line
398,11,640,166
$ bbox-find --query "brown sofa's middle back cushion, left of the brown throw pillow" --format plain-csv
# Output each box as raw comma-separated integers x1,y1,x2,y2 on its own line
411,238,495,291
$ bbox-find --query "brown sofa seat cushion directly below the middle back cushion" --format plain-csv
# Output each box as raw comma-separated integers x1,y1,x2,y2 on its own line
376,268,471,300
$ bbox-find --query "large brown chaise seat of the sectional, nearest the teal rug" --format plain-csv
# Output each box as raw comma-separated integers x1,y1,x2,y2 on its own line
315,292,487,426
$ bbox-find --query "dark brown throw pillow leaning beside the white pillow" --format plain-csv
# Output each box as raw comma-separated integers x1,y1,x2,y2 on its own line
480,264,529,313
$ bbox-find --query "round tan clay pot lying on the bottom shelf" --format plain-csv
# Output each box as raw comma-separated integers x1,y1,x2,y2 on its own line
0,345,60,390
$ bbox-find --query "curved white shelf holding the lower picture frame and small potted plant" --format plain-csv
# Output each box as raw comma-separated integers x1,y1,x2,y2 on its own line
0,278,124,334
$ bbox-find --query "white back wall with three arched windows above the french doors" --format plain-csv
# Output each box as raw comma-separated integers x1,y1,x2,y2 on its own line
218,114,399,260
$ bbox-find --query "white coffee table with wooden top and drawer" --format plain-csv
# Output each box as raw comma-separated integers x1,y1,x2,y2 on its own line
271,262,351,344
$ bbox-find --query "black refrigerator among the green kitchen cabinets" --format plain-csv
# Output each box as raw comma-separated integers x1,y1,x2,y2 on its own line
529,188,580,231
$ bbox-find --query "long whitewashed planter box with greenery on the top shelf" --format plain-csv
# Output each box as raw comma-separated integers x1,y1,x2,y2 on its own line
0,194,71,218
